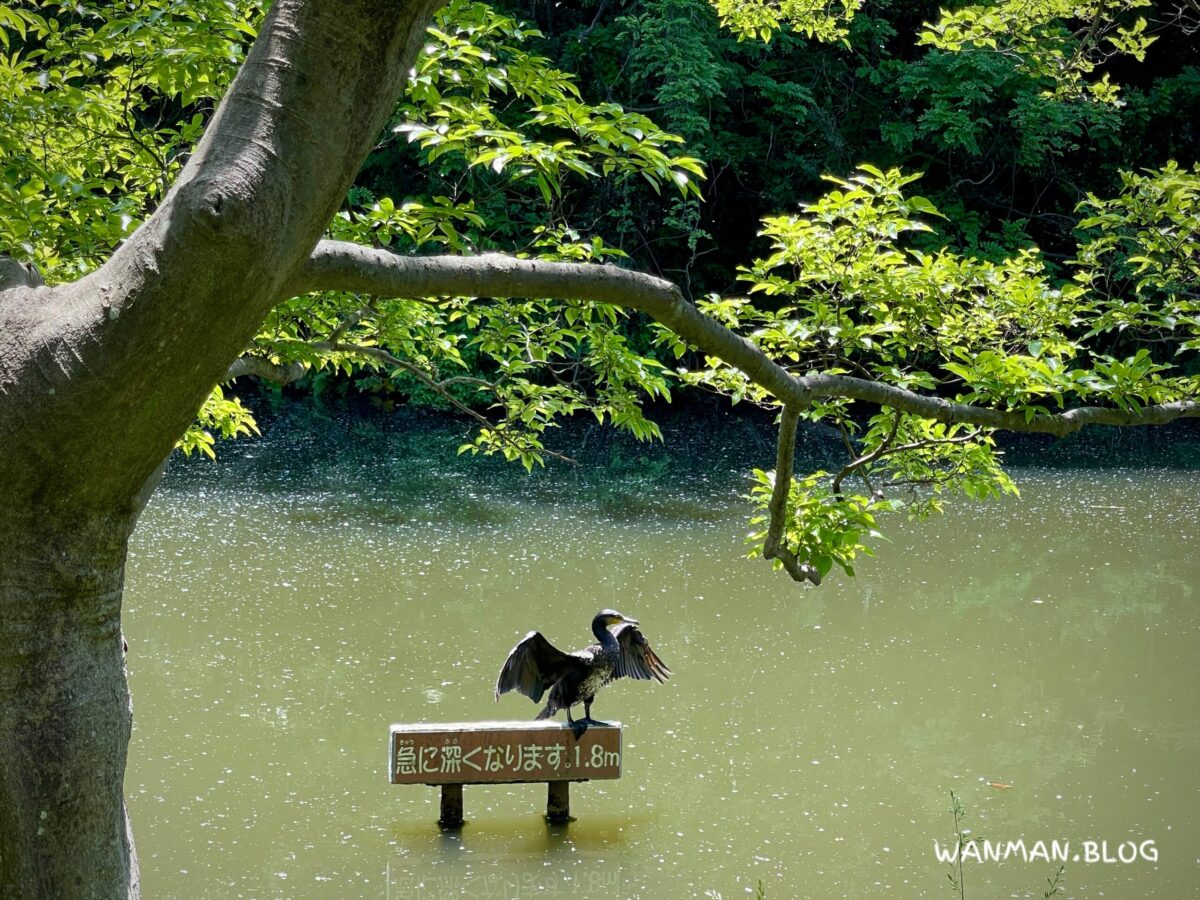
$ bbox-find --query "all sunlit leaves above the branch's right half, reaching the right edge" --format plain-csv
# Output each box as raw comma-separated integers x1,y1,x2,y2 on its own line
689,168,1196,413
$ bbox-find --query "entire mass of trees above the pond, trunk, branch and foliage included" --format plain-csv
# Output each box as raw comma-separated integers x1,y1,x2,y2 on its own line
0,0,1200,896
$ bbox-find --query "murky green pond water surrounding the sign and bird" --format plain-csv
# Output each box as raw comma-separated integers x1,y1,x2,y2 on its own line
126,415,1200,898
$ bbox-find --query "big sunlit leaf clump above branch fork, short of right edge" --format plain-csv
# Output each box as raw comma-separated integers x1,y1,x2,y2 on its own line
702,167,1079,385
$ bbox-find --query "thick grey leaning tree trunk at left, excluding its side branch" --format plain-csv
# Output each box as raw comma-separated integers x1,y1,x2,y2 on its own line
0,0,438,899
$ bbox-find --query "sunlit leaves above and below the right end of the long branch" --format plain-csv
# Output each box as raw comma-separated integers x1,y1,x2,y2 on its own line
691,167,1200,575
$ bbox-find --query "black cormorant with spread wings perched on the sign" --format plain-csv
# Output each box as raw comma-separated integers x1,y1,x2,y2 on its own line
496,610,671,738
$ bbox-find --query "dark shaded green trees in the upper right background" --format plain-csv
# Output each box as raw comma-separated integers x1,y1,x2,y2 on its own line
381,0,1200,285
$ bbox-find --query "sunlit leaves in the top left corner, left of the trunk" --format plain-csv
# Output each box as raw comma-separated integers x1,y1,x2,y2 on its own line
0,0,259,277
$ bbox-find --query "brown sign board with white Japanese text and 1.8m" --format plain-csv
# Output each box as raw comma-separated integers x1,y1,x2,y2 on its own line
388,721,620,785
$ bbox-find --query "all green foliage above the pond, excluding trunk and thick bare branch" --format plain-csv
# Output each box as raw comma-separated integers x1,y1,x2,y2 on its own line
0,0,1200,582
